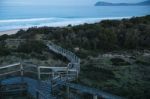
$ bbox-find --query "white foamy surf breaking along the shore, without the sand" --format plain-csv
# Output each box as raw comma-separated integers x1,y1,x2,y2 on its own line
0,17,130,31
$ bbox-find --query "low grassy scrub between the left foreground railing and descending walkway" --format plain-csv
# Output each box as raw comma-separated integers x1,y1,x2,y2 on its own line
0,38,67,66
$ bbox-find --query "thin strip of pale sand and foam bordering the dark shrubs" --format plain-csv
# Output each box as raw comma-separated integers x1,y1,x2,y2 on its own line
0,17,131,36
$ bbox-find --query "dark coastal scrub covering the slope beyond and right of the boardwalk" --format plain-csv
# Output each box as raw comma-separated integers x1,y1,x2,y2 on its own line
0,15,150,99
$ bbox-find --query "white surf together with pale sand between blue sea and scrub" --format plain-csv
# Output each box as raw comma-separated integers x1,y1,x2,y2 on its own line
0,17,131,35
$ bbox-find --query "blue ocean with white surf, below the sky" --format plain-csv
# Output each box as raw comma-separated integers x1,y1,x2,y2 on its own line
0,4,150,31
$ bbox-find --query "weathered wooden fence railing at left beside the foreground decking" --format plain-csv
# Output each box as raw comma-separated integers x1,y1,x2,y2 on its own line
0,62,68,80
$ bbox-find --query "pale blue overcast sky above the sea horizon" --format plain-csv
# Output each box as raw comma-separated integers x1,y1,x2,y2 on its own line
0,0,145,5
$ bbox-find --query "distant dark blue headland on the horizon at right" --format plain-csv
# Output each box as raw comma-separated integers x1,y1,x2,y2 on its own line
95,0,150,6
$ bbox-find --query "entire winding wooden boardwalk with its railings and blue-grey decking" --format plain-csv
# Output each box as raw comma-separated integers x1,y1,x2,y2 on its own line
0,42,123,99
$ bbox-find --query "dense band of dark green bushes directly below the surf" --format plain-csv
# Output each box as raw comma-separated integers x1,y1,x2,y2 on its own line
9,16,150,51
